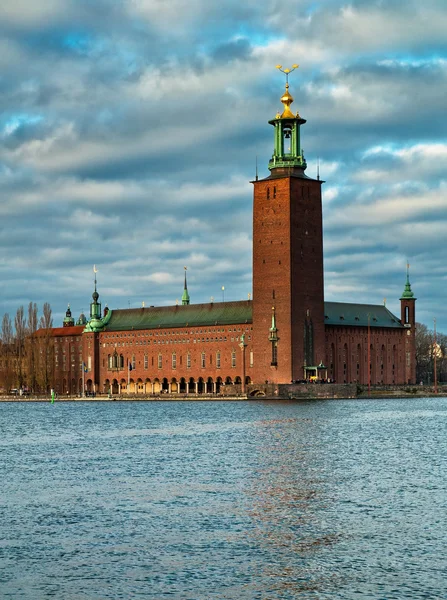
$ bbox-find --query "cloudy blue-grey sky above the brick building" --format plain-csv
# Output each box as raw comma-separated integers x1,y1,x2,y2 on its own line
0,0,447,333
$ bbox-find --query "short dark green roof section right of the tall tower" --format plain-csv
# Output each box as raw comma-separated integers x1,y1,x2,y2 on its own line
324,302,403,329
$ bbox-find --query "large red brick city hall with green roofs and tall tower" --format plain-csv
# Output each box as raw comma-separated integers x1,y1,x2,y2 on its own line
44,76,416,395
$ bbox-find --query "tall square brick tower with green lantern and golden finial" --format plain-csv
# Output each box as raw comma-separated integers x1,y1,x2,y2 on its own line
253,65,326,383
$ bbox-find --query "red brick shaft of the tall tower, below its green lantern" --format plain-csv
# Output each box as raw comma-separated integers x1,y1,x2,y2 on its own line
253,177,324,383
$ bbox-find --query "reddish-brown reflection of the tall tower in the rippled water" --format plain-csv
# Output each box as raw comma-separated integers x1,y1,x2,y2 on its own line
246,418,341,598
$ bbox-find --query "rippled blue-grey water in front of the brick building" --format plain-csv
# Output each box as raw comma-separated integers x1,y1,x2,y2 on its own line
0,398,447,600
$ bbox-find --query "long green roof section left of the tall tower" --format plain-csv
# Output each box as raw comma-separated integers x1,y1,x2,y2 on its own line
104,300,252,331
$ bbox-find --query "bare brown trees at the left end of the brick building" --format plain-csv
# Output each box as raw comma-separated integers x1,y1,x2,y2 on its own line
0,302,54,393
